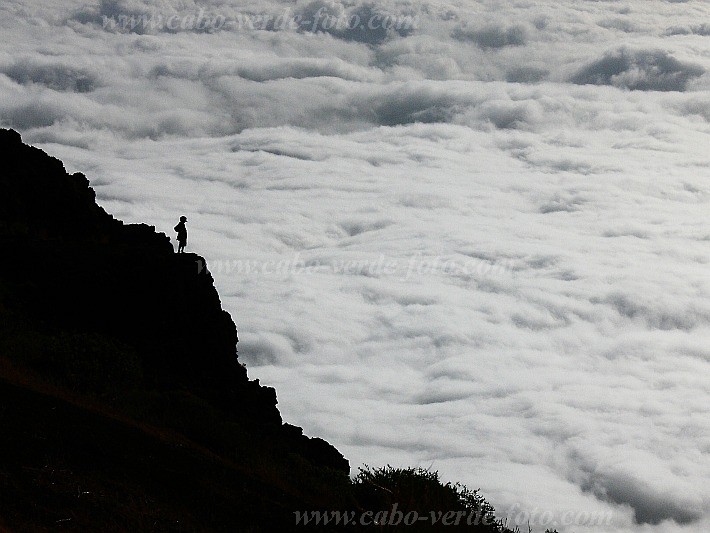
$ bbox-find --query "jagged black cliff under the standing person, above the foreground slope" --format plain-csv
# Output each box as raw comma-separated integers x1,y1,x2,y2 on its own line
0,130,349,474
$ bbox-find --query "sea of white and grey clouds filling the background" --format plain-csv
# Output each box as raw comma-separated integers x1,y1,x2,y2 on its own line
0,0,710,533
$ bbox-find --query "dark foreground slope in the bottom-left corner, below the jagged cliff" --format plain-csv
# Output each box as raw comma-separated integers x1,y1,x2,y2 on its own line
0,380,313,532
